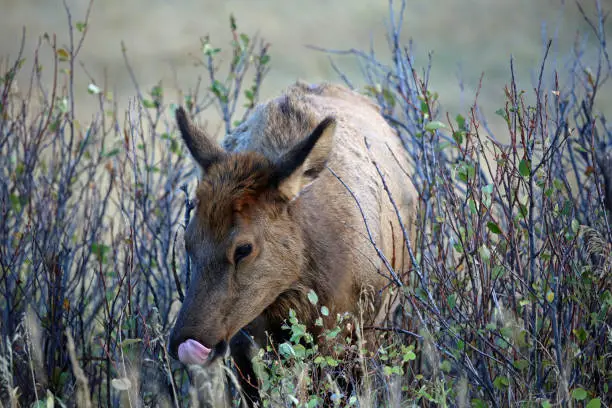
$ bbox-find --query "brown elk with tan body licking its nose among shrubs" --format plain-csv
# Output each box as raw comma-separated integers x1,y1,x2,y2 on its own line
169,82,417,404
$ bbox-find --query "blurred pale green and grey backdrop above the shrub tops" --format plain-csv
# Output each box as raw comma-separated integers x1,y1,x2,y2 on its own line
0,0,612,138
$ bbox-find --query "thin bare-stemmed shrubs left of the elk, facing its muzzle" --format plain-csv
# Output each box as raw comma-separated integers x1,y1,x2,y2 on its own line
0,2,269,407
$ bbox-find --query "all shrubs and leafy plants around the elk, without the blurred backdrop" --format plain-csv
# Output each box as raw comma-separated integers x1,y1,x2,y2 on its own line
0,3,612,408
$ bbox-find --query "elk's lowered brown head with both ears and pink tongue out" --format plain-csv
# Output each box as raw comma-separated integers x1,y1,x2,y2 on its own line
170,108,336,364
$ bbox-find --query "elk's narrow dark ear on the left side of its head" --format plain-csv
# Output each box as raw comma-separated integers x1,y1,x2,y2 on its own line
175,106,226,172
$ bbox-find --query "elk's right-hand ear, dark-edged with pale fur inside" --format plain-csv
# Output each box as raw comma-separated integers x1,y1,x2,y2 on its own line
271,116,336,201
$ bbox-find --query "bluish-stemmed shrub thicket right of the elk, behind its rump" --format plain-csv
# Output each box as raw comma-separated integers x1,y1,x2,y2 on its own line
310,1,612,406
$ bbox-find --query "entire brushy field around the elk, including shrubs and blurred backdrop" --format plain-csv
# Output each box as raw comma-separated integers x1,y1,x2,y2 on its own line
0,0,612,408
